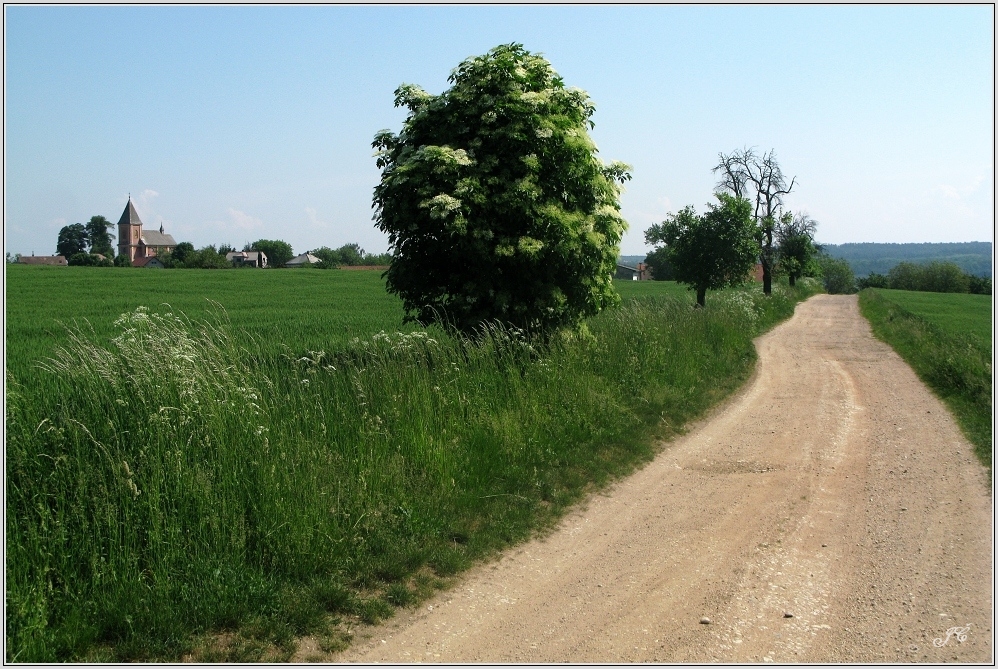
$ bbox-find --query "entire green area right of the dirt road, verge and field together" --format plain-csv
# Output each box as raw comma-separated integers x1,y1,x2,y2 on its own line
859,288,994,469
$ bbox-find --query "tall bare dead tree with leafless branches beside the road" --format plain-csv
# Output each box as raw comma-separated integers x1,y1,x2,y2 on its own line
713,149,797,295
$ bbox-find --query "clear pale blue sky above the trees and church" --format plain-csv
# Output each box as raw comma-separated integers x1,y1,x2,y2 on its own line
4,5,994,254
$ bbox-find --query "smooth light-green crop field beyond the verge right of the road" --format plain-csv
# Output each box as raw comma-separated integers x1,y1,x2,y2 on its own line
878,289,991,342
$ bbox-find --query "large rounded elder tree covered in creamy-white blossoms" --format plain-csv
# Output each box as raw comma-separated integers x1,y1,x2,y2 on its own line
373,44,630,336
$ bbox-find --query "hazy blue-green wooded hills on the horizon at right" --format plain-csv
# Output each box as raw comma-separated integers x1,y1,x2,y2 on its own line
822,242,992,277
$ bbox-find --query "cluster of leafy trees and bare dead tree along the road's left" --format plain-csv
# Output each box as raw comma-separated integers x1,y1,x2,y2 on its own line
645,149,821,306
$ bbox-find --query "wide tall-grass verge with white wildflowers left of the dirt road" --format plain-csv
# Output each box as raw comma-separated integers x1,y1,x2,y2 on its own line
6,283,813,662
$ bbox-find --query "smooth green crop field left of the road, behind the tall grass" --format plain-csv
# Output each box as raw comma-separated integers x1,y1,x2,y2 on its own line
6,264,692,377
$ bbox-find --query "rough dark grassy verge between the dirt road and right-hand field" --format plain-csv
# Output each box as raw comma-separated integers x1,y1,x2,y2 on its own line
859,288,994,471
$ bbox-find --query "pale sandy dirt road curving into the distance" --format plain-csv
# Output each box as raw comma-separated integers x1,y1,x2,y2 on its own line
331,295,994,662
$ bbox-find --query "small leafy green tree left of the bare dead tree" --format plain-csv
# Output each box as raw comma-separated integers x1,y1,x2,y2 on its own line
645,193,759,307
